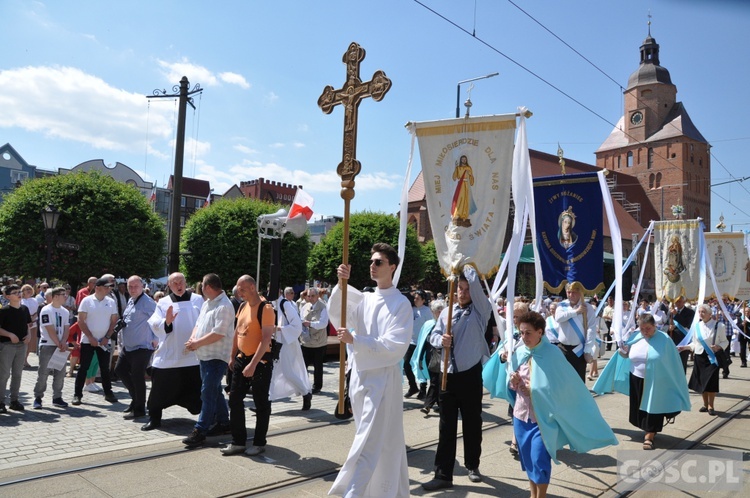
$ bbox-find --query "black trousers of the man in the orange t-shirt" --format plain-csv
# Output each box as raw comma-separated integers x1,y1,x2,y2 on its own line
229,357,273,446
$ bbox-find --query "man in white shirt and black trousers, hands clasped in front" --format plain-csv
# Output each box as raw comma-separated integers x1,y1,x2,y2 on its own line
73,278,119,406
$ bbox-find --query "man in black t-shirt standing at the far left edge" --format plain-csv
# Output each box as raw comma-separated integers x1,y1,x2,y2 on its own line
0,284,32,413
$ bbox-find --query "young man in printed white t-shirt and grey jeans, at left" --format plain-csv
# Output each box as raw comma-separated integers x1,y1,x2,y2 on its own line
34,287,70,410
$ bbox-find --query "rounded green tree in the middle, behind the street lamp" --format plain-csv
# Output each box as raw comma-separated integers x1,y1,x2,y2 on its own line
180,198,310,290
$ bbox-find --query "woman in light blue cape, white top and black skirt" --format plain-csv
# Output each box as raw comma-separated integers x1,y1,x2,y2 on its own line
593,313,690,450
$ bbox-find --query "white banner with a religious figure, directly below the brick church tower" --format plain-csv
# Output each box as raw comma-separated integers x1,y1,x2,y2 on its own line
654,220,703,302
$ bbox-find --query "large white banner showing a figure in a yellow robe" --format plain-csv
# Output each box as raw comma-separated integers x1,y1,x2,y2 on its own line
412,114,516,278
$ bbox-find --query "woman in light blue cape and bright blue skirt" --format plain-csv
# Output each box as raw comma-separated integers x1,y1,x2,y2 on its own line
500,311,617,498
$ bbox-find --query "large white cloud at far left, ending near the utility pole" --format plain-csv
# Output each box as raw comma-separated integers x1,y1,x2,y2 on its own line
0,66,174,151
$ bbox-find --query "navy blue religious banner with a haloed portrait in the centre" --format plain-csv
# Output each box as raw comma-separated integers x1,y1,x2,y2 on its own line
534,173,604,294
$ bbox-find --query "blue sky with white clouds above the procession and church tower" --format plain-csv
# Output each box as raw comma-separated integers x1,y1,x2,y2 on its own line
0,0,750,229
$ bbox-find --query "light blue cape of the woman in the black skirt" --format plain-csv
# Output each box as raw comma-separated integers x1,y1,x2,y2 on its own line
592,330,690,414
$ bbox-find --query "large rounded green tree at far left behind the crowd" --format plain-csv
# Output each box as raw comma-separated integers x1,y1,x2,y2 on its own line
0,172,166,286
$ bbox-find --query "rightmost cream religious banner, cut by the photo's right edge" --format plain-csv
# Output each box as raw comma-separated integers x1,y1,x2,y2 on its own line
705,233,747,299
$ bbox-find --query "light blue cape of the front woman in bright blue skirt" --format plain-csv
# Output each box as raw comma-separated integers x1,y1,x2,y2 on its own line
483,336,618,463
